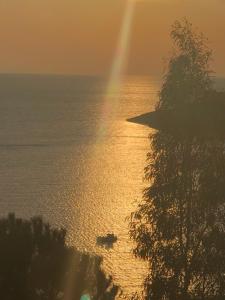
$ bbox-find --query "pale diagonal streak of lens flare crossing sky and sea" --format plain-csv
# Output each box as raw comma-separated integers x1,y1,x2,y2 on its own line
98,0,136,139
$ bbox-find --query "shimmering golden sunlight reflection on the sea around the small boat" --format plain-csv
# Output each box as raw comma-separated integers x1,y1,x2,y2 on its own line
67,78,157,295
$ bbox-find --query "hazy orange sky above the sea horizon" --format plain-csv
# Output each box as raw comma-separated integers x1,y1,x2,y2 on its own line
0,0,225,75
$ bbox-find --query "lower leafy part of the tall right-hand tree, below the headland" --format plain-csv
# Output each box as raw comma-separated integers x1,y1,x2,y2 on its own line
131,132,225,300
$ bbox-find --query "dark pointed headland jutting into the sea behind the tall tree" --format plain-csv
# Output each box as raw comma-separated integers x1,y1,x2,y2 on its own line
127,91,225,136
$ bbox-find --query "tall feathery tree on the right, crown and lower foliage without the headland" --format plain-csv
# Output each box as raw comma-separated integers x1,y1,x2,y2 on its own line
130,21,225,300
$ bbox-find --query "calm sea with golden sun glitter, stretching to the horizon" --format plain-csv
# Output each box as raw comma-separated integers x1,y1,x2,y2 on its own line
0,74,160,299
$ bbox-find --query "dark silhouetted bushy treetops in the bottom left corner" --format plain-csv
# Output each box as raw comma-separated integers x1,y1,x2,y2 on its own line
0,214,119,300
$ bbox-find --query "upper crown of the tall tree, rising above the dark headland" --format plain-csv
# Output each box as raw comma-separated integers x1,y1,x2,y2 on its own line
158,20,212,109
